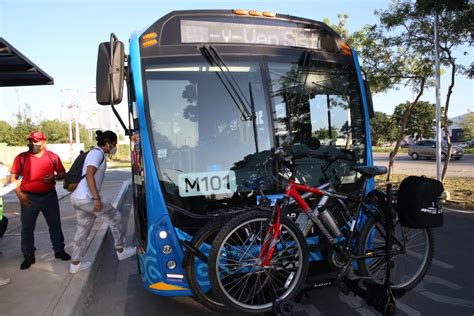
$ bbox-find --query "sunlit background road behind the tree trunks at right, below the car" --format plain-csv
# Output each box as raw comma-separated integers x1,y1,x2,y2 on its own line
374,153,474,178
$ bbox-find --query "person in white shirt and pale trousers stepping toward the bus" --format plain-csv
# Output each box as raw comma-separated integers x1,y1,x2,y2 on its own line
69,131,136,273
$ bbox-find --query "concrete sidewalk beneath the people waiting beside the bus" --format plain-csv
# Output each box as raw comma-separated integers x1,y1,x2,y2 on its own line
0,176,130,316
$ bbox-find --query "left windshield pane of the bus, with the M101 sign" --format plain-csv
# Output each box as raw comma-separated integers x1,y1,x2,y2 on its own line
145,60,271,227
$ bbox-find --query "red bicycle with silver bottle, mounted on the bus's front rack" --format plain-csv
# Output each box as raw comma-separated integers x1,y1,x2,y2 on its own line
208,148,433,313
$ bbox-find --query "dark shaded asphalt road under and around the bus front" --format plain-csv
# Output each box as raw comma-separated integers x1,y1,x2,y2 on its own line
85,192,474,316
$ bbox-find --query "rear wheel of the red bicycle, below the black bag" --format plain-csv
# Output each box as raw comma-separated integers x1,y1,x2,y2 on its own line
358,218,434,290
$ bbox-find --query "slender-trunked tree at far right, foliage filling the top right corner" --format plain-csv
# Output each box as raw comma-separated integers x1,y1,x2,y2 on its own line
377,0,474,180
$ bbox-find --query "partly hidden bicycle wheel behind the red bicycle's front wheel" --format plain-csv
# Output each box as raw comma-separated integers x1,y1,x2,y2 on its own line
183,221,228,312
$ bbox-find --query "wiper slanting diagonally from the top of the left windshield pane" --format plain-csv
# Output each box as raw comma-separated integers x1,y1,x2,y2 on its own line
200,45,255,121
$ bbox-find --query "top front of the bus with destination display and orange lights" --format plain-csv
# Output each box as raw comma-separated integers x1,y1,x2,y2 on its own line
135,10,350,55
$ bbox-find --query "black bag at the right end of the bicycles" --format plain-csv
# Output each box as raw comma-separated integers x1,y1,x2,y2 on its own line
396,176,444,228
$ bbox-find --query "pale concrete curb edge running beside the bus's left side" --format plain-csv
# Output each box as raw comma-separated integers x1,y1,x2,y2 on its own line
49,180,131,316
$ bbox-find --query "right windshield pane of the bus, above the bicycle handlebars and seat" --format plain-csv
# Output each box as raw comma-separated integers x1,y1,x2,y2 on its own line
269,59,365,185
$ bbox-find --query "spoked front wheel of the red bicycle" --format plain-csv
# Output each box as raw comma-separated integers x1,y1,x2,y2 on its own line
208,211,308,313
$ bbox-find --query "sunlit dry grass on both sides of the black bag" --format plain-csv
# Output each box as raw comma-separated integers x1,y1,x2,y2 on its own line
375,174,474,210
